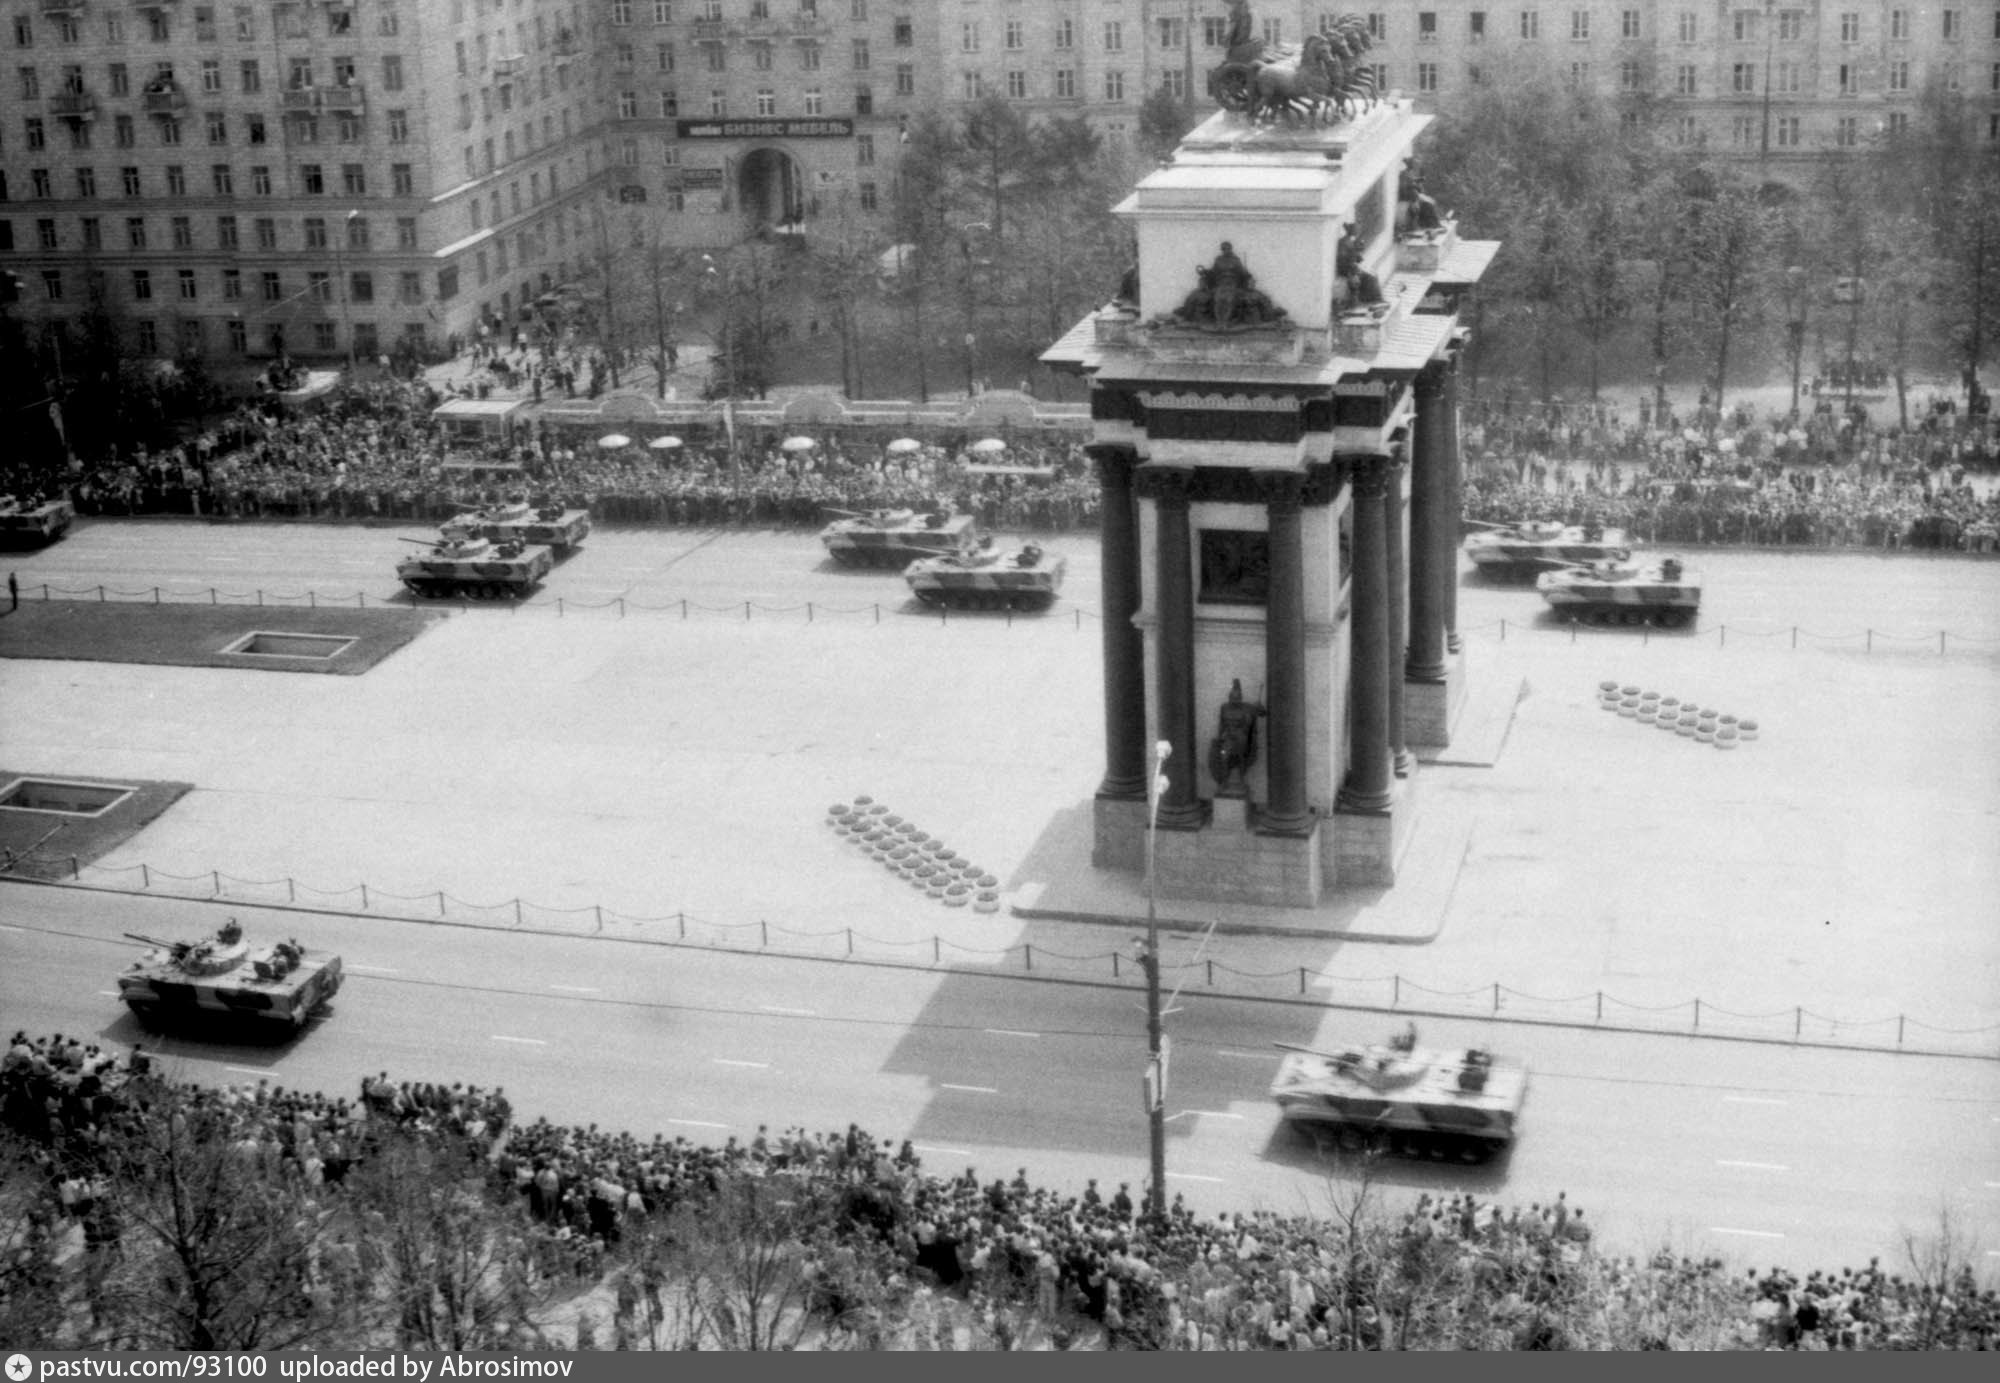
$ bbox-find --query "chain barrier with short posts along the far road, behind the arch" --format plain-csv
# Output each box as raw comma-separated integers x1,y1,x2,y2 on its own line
11,582,2000,658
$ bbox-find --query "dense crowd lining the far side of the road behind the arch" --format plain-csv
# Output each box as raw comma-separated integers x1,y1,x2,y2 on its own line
0,382,2000,552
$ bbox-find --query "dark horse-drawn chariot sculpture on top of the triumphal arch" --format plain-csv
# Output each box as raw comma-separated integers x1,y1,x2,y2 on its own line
1208,0,1376,124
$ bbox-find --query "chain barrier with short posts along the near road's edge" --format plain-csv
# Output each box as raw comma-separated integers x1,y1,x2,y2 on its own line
0,855,2000,1059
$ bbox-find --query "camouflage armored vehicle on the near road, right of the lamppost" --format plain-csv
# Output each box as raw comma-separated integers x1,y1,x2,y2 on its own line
1270,1027,1528,1163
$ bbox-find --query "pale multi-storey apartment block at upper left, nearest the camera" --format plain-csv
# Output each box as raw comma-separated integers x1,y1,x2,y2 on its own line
0,0,604,358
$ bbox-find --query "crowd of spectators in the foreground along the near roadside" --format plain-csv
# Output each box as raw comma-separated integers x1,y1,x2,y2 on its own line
0,1033,2000,1349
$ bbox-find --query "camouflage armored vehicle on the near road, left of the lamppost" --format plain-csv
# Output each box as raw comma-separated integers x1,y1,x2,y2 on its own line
118,917,340,1035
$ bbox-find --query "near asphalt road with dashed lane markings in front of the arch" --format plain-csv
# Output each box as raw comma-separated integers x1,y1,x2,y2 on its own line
0,887,2000,1267
